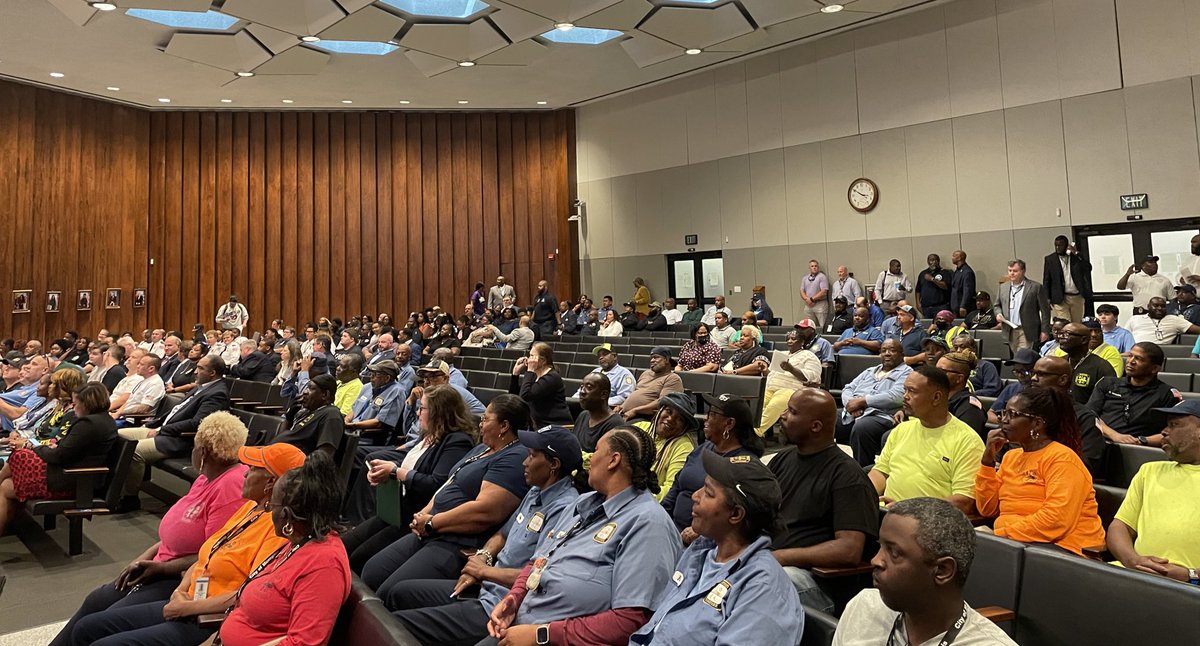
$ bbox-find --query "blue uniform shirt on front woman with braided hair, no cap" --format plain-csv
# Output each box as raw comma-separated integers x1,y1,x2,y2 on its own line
514,486,686,624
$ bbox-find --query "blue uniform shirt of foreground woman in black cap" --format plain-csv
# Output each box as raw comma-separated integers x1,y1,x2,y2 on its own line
629,536,804,646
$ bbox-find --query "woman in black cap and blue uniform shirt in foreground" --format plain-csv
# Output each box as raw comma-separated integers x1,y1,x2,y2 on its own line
629,450,804,646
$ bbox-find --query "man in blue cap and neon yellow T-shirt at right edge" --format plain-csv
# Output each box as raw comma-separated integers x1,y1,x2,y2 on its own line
1108,400,1200,585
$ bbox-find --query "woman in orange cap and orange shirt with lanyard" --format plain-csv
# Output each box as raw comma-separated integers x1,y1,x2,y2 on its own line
71,441,307,646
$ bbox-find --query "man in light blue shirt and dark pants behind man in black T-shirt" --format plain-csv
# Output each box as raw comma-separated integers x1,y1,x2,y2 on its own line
836,339,907,463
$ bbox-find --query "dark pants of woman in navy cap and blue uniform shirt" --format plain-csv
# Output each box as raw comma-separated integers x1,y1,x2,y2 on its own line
392,580,487,646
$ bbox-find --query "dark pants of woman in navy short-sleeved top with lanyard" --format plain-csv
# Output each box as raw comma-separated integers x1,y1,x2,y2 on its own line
362,534,467,610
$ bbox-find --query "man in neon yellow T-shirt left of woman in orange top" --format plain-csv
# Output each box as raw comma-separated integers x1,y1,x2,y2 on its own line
868,366,983,514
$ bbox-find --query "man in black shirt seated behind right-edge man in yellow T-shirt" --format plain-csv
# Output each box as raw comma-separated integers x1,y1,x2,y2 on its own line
1087,338,1181,447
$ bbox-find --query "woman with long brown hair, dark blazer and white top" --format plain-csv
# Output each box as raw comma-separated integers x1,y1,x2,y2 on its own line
342,385,475,559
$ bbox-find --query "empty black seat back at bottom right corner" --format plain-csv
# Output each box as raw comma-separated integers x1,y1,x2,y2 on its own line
1013,546,1200,646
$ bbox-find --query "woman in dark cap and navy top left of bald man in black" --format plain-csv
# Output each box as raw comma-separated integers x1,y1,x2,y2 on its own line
662,395,763,533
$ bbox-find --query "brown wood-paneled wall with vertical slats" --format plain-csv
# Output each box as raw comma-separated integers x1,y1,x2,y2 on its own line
0,83,578,337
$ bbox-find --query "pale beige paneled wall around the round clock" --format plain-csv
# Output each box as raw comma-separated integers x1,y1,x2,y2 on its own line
568,0,1200,318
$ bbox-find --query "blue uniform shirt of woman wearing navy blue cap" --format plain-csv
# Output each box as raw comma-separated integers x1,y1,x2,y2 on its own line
479,477,580,615
